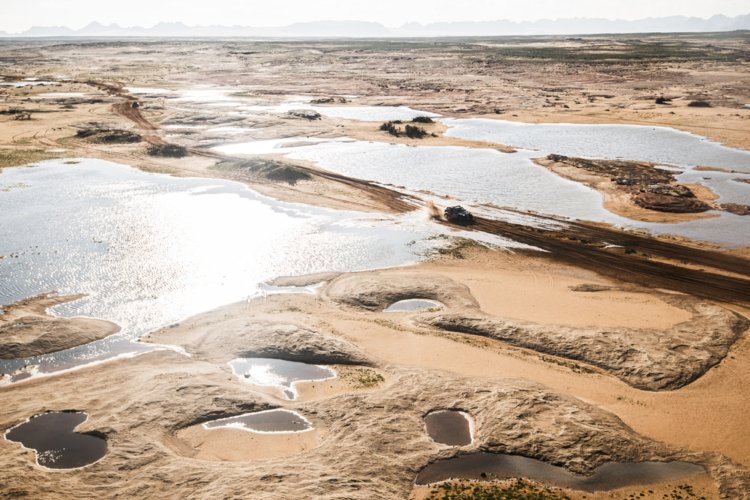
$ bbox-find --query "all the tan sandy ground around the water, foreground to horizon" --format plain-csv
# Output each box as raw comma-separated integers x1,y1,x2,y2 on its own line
0,34,750,499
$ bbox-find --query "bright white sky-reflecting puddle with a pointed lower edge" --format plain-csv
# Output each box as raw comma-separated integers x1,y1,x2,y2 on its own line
229,358,336,400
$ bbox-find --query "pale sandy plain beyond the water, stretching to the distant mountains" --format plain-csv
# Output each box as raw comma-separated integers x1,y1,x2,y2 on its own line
0,34,750,216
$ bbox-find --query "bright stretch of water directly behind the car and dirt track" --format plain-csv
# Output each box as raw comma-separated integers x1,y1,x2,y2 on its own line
276,139,750,246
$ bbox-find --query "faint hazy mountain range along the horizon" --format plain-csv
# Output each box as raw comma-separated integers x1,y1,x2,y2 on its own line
0,14,750,38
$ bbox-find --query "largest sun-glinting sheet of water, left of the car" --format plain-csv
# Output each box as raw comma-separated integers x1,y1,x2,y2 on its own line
0,160,441,373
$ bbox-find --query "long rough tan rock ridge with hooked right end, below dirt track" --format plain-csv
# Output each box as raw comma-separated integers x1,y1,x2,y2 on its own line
420,297,750,391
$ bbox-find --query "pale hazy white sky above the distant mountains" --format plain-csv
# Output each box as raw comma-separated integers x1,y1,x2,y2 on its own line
0,0,750,32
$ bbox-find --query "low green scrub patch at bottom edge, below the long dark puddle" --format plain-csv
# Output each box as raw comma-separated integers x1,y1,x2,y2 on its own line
427,479,570,500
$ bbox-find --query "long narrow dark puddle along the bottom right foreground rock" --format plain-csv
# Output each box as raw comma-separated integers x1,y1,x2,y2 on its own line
416,453,706,491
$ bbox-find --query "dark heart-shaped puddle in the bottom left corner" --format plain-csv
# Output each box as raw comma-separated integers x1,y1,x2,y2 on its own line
5,411,107,469
